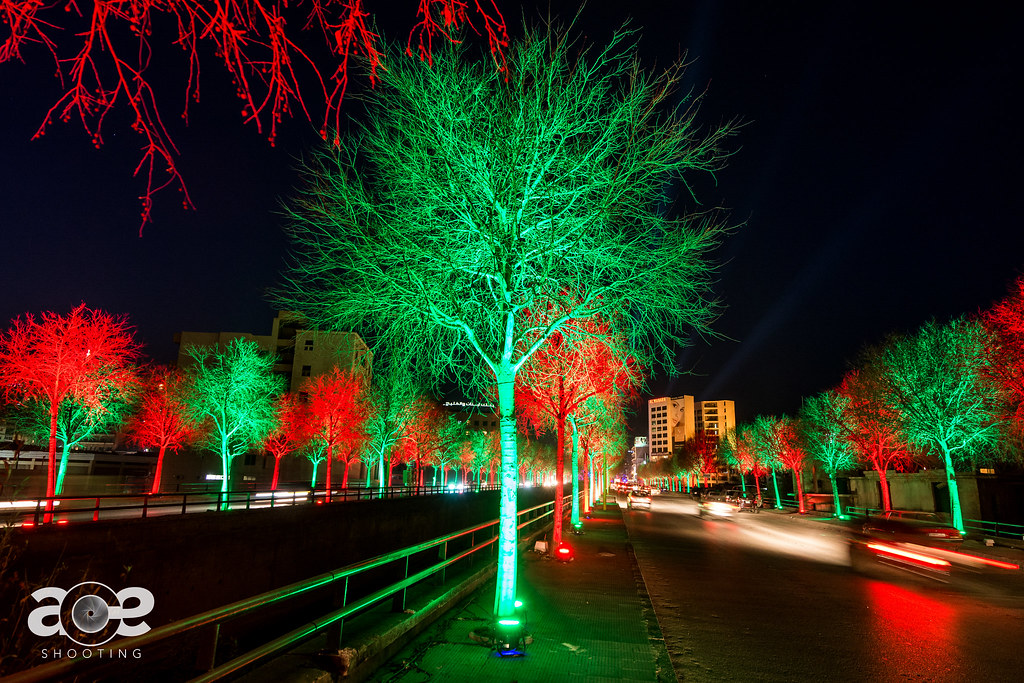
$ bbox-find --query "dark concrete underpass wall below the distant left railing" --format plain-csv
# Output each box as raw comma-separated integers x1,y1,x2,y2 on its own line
14,488,553,626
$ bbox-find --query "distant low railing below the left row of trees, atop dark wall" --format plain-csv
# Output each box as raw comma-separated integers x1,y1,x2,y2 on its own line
0,484,500,527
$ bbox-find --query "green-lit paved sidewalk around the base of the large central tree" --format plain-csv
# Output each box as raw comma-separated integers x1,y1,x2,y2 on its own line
369,505,676,683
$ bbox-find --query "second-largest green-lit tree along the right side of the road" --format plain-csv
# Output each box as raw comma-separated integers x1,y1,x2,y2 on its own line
800,391,857,517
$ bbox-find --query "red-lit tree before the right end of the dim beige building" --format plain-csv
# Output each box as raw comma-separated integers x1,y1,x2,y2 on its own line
303,367,369,501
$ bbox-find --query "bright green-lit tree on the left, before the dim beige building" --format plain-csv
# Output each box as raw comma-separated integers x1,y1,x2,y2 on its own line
183,339,285,508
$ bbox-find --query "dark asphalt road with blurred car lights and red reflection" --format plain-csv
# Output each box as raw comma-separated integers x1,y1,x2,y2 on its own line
623,495,1024,682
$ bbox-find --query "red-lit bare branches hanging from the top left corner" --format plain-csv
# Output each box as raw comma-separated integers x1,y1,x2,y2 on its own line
0,0,508,229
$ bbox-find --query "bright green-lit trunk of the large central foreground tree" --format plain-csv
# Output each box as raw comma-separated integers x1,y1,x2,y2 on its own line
495,371,520,618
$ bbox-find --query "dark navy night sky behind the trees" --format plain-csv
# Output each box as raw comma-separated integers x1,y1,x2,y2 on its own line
0,0,1024,430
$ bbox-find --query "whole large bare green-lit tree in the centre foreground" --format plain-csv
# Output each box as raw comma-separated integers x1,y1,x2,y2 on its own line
279,22,734,617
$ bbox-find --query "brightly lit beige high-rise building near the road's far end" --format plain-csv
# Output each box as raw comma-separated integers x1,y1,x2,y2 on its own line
647,395,736,460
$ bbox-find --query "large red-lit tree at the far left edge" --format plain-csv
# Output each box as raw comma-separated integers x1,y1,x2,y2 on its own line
0,304,138,521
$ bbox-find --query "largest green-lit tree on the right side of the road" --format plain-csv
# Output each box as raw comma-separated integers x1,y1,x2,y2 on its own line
880,317,1002,532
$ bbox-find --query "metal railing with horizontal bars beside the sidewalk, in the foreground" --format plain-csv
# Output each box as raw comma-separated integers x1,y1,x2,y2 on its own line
4,496,571,683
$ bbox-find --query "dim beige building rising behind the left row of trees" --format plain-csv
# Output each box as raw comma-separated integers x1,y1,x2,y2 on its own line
174,311,374,392
